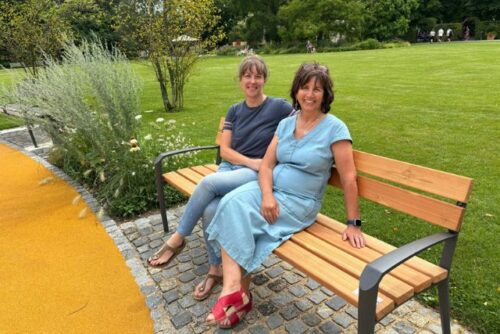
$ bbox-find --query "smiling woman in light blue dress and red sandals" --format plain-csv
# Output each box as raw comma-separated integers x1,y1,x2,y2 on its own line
206,64,364,328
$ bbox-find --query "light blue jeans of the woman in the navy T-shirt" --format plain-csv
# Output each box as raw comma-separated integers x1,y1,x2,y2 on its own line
177,161,257,265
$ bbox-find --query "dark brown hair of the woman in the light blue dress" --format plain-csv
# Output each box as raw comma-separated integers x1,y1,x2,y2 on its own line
290,63,334,114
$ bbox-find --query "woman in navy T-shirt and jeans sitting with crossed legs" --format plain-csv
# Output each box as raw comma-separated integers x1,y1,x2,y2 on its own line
148,55,293,300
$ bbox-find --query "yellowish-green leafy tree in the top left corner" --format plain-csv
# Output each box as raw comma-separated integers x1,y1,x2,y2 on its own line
0,0,68,77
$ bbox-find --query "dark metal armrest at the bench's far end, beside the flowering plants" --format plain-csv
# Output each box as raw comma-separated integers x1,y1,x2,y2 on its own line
155,145,220,232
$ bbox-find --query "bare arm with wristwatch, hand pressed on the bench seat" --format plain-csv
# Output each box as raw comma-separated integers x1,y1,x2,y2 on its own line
332,140,365,248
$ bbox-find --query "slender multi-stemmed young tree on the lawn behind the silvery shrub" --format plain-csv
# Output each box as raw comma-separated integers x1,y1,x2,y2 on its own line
121,0,222,111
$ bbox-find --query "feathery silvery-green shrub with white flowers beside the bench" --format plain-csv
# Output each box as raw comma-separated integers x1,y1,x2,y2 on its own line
7,41,197,216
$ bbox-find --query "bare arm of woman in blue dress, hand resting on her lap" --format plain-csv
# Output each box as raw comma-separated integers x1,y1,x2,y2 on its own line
259,136,280,224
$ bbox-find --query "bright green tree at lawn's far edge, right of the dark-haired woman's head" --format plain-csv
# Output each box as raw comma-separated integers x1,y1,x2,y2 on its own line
364,0,419,41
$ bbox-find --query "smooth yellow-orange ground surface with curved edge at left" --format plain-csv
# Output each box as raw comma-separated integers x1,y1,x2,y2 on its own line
0,144,153,334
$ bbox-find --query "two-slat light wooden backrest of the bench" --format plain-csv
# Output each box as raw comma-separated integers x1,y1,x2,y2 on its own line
215,117,473,232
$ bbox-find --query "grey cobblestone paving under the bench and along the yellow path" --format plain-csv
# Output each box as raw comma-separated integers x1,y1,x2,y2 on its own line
0,129,473,334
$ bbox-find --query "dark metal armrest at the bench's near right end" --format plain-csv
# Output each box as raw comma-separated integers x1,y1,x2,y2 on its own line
358,231,458,334
